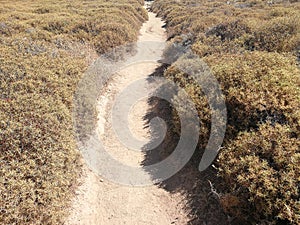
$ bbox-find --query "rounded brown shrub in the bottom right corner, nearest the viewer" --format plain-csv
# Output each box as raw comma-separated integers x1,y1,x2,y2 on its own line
219,123,300,224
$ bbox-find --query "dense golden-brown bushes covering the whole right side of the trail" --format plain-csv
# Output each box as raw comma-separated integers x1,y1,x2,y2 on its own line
153,0,300,224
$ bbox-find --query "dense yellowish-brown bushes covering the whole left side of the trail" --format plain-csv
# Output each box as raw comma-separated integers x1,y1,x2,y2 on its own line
0,0,147,224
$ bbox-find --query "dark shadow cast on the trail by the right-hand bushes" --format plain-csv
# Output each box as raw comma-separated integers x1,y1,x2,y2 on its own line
142,65,241,225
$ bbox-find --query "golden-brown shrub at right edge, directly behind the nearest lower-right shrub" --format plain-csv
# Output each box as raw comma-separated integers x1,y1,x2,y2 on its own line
206,52,300,138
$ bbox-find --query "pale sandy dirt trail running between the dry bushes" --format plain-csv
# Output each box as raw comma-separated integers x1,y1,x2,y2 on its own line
65,3,188,225
